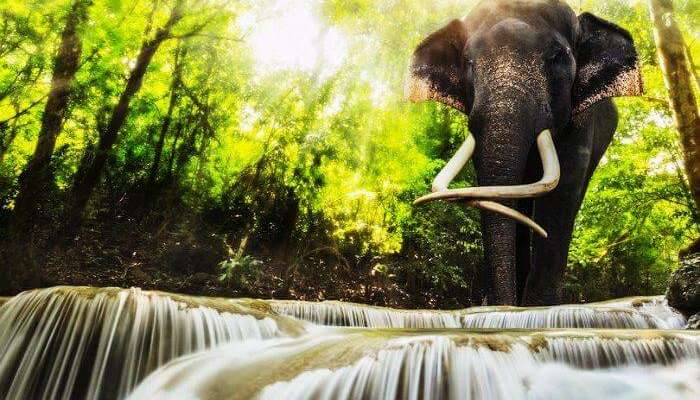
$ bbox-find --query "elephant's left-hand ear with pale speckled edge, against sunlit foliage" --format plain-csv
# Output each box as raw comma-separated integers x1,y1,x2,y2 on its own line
404,19,468,112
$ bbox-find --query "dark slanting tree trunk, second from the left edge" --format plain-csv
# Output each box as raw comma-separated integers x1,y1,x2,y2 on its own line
66,4,182,231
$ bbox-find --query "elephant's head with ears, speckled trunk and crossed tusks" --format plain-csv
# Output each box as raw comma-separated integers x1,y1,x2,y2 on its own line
405,0,642,304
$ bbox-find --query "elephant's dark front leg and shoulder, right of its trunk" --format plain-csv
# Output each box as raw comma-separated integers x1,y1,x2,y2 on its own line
522,101,617,305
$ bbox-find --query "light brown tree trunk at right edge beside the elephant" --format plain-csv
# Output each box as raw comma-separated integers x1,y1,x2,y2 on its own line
649,0,700,210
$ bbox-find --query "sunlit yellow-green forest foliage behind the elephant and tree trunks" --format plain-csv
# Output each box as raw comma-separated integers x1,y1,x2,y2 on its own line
0,0,700,304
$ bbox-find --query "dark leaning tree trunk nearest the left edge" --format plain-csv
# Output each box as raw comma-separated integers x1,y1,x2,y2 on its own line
15,0,92,230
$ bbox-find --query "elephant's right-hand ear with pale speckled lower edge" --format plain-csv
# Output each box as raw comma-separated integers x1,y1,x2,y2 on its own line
573,13,643,114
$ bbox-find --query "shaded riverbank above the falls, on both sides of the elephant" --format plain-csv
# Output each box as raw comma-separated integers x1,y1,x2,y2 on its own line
0,203,688,309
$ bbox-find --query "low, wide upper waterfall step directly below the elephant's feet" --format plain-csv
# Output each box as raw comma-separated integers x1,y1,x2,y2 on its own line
270,296,685,329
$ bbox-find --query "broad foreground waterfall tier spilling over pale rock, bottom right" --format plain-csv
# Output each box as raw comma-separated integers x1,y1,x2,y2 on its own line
130,330,700,400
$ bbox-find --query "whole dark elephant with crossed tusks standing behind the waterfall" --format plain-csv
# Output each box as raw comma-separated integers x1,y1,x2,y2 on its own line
405,0,643,305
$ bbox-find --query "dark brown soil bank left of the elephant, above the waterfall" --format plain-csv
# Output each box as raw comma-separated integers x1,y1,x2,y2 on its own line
0,214,460,308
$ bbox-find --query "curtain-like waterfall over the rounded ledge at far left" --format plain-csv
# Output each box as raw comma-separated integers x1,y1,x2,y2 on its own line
0,287,288,399
